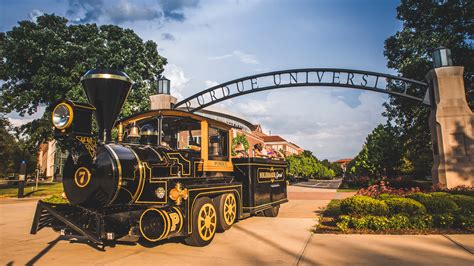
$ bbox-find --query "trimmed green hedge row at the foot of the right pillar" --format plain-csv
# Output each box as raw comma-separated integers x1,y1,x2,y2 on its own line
337,192,474,231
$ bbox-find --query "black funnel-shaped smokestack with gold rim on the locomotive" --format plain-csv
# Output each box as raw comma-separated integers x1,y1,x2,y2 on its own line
81,69,133,142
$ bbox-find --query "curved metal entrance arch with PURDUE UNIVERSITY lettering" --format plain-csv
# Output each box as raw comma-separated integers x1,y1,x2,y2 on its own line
173,68,431,112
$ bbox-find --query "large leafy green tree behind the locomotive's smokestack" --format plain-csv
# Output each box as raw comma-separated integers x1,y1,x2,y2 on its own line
0,14,166,150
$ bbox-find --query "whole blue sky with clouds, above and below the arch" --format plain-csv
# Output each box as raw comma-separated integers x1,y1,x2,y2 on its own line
0,0,401,159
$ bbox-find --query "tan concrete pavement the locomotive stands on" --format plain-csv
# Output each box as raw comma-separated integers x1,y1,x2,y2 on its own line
0,186,474,265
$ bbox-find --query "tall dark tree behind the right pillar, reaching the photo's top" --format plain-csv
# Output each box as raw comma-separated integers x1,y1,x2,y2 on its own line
384,0,474,175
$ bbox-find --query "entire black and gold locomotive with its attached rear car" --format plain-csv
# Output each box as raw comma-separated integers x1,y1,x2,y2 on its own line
31,70,288,246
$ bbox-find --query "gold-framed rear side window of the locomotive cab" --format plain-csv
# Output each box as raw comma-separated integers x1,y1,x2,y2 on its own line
209,126,229,161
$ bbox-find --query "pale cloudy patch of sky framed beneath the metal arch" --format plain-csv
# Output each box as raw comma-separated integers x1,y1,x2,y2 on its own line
228,89,385,160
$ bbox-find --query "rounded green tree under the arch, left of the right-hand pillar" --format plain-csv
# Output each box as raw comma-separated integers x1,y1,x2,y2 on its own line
350,124,404,177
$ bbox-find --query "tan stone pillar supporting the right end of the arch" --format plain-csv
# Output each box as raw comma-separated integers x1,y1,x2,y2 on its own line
426,66,474,188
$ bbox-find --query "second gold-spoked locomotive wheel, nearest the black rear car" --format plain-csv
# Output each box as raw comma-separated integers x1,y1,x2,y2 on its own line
214,193,237,232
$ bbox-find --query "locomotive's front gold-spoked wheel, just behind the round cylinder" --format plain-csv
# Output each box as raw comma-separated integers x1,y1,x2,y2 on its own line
184,197,217,247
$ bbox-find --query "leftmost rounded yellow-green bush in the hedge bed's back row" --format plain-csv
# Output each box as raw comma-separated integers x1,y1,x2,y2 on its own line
341,196,388,216
